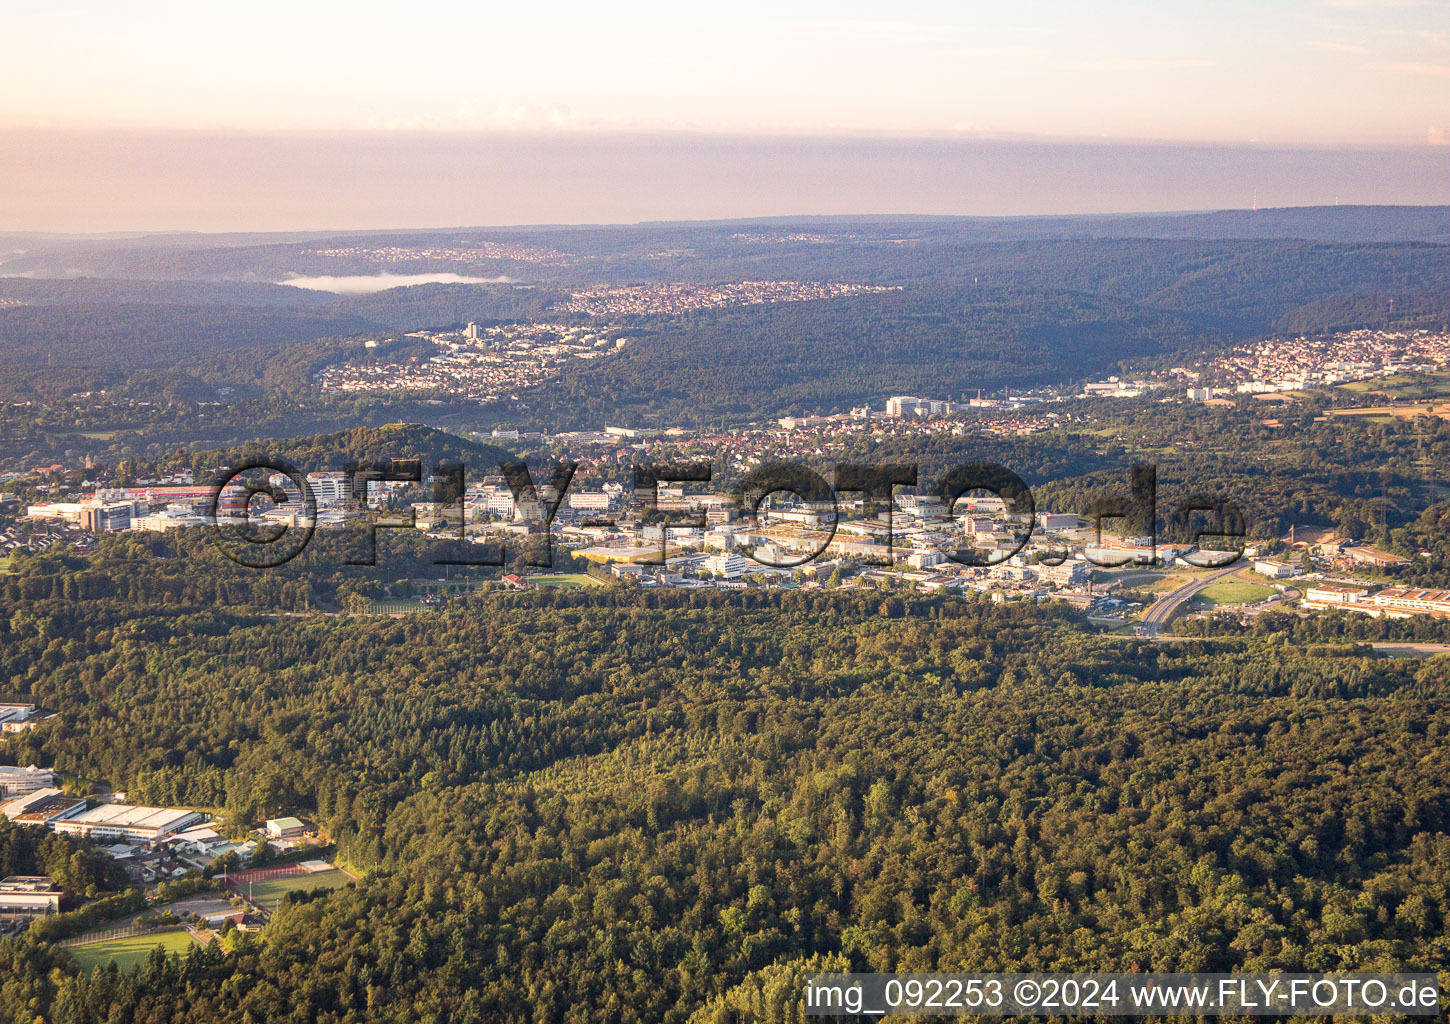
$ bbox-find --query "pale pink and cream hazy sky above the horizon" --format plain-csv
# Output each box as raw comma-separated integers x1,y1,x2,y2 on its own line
0,0,1450,231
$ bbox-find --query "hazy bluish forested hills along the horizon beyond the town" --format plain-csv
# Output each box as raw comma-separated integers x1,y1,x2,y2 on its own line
0,207,1450,426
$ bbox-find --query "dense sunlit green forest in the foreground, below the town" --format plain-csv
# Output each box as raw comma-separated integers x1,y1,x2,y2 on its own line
0,592,1450,1021
